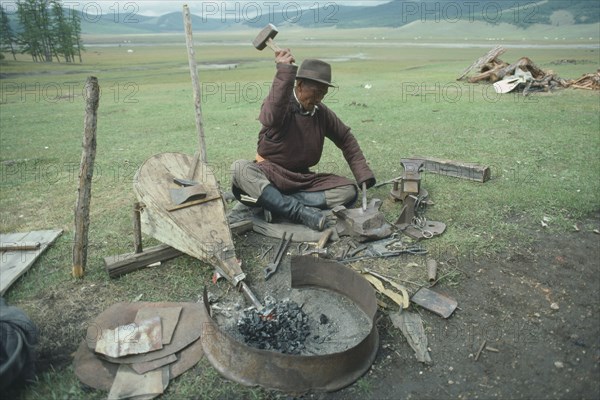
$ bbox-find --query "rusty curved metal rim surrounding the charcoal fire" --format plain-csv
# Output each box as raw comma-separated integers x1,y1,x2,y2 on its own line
201,256,379,394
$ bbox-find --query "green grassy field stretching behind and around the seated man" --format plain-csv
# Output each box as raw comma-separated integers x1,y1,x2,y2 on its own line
0,26,600,398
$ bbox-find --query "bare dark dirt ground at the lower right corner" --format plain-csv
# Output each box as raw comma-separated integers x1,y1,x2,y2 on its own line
311,214,600,399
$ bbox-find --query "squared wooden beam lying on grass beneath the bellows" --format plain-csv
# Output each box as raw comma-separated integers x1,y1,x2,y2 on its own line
104,244,183,278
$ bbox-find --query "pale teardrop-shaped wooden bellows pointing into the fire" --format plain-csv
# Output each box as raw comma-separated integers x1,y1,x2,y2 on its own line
133,153,243,280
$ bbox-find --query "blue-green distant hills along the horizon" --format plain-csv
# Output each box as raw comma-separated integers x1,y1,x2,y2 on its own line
4,0,600,35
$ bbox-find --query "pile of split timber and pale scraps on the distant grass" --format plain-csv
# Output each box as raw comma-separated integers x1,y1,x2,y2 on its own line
457,46,600,95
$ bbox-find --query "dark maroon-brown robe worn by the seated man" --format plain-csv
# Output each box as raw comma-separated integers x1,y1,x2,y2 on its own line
257,64,375,193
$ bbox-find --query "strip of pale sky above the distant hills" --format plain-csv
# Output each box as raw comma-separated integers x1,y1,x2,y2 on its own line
7,0,390,18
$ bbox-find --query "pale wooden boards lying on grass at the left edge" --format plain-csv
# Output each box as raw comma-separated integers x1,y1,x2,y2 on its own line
0,229,63,295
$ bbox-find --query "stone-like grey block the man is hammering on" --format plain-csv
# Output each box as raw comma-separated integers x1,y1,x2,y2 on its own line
332,199,392,242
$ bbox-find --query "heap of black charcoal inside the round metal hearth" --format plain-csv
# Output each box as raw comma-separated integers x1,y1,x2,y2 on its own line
237,300,311,354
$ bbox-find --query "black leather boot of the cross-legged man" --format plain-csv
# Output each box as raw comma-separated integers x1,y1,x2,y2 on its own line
257,185,326,231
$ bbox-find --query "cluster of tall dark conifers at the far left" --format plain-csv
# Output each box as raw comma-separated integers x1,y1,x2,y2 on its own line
0,0,83,62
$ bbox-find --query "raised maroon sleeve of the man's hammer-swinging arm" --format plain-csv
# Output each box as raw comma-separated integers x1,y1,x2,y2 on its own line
258,64,298,128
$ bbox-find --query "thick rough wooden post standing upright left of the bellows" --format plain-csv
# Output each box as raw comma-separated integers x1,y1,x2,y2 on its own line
72,76,100,278
